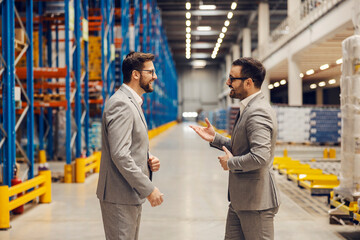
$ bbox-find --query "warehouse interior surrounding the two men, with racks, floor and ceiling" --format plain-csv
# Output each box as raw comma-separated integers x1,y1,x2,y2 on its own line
0,0,360,240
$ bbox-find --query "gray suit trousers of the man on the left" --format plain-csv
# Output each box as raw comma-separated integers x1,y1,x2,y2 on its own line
100,201,142,240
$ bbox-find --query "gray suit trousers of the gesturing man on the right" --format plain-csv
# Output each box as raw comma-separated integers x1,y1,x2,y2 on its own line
225,204,279,240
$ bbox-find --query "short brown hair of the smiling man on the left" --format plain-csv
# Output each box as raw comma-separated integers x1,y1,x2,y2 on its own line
122,52,155,83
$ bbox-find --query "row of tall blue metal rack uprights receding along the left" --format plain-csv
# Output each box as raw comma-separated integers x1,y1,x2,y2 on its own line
0,0,177,188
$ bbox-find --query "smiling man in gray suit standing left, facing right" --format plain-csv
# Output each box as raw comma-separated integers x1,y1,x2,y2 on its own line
96,52,163,240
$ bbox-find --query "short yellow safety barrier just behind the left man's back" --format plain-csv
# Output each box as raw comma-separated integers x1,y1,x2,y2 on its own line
75,152,101,183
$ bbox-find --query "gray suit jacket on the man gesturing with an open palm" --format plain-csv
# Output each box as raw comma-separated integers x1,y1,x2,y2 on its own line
210,93,280,210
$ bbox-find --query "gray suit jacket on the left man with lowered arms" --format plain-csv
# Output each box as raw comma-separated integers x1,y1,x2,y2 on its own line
96,86,154,205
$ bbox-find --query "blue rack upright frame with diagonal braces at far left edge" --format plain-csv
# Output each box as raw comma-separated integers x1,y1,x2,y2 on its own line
0,0,34,186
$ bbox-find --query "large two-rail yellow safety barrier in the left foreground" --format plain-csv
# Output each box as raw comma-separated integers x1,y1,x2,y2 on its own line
0,170,51,229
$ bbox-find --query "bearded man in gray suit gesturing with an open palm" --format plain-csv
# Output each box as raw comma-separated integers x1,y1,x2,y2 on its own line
190,58,280,240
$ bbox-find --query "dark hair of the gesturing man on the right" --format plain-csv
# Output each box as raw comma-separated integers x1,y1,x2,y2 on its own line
232,57,266,88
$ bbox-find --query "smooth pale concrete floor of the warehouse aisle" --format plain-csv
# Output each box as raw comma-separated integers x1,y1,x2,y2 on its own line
0,123,360,240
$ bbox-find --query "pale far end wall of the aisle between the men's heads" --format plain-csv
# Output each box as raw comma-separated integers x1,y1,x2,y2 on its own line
178,66,222,115
